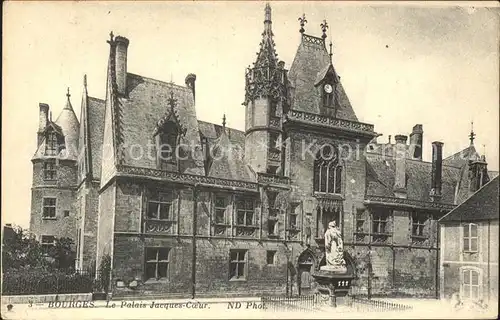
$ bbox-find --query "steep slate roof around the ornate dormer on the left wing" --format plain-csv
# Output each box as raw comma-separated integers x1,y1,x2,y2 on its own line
118,73,204,175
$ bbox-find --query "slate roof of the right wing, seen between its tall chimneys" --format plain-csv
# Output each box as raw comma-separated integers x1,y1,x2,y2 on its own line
366,154,460,204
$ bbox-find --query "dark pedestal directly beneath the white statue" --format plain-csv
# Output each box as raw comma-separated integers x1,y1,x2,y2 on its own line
312,266,354,308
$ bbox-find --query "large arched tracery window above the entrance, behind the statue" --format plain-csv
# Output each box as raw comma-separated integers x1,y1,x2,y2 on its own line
314,146,342,194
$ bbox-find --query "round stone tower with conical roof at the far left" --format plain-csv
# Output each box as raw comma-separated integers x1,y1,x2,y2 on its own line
30,89,80,249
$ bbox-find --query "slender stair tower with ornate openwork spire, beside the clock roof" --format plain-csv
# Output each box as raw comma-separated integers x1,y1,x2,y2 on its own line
243,3,287,174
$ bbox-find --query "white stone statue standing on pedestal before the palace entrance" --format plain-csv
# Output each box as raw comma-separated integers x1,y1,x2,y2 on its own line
320,221,347,272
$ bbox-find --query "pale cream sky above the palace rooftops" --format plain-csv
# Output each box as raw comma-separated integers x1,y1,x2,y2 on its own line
2,1,500,227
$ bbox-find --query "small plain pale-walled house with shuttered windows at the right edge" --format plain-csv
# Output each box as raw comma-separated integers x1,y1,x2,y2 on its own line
439,177,499,304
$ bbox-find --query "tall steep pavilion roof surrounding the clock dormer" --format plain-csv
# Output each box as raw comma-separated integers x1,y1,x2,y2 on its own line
288,34,358,121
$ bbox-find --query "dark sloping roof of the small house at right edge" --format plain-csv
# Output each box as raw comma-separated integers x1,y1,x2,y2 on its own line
439,176,499,223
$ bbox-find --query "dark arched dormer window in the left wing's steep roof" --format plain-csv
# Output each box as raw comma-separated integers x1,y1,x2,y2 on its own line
158,121,179,170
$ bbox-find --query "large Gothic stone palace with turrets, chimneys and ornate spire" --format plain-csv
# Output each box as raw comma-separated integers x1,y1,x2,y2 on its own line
31,5,491,297
